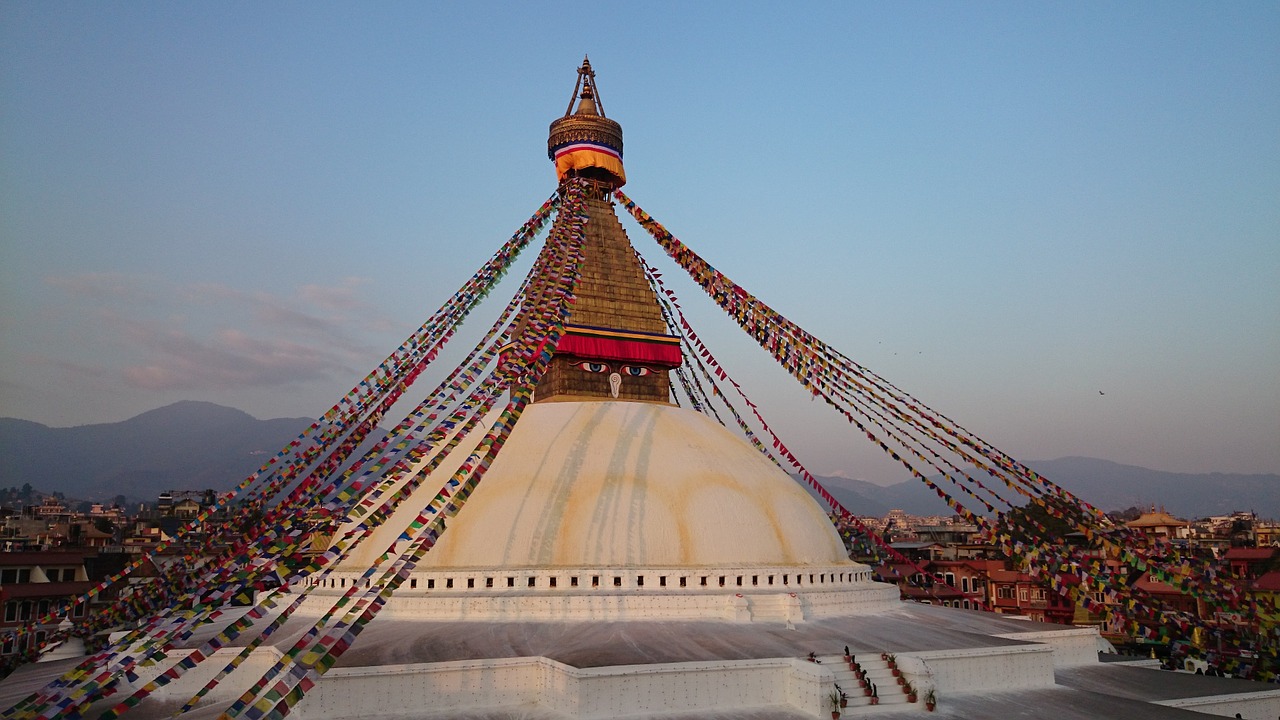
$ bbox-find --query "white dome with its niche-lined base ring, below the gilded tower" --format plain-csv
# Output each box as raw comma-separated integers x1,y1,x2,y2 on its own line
314,398,897,623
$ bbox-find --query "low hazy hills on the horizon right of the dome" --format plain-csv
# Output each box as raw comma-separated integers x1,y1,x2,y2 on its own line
798,457,1280,519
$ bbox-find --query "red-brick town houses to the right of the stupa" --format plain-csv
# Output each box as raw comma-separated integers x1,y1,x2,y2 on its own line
852,509,1280,679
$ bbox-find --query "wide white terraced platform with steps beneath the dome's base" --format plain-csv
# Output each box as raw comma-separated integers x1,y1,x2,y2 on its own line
0,602,1280,720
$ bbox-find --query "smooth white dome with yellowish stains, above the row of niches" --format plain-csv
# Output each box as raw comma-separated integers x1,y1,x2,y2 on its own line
419,401,847,568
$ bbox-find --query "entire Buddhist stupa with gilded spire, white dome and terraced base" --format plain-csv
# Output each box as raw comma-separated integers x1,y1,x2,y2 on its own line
0,61,1280,720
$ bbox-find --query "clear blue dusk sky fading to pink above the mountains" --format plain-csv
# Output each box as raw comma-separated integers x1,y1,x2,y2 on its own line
0,1,1280,482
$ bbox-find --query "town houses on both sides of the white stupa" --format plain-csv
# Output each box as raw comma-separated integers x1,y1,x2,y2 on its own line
0,491,1280,675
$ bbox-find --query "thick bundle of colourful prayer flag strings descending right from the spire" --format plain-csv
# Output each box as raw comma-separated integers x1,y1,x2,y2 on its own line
614,191,1240,655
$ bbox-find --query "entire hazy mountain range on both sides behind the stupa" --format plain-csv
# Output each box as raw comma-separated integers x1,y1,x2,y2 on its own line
0,401,1280,519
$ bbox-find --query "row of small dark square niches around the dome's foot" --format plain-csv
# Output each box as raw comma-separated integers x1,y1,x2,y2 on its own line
301,569,872,592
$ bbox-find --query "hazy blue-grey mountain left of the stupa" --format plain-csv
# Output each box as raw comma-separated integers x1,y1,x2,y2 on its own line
0,401,311,500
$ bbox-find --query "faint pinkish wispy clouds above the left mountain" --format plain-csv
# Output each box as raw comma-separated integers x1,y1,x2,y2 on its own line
47,273,389,391
